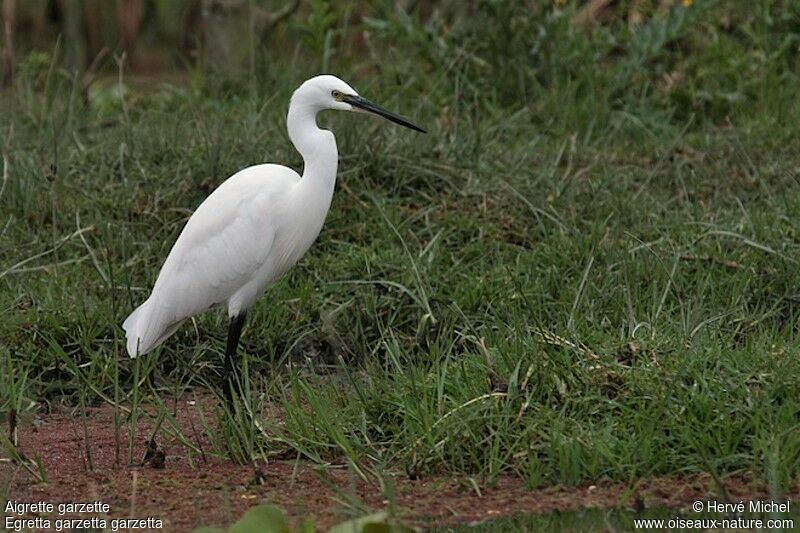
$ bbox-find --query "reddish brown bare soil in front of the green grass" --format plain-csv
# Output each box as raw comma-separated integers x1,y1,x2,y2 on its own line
0,402,800,531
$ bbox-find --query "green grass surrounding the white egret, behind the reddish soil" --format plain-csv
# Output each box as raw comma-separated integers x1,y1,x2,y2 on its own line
0,0,800,493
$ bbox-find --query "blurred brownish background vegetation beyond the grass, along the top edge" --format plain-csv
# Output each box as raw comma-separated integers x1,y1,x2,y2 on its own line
2,0,712,79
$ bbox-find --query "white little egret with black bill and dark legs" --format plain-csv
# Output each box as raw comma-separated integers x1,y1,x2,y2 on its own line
122,75,425,403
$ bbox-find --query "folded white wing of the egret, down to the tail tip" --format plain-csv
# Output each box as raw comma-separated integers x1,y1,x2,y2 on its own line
123,165,300,356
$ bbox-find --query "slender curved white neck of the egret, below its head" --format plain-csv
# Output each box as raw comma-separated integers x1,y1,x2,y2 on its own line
286,102,339,193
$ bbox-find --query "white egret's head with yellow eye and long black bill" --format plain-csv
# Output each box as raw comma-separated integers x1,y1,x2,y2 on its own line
292,74,426,133
